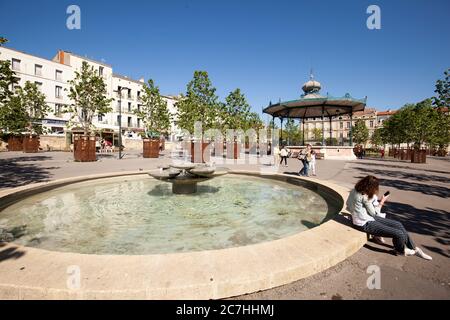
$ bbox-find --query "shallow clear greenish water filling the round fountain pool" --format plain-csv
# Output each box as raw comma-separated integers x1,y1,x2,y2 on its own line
0,174,329,255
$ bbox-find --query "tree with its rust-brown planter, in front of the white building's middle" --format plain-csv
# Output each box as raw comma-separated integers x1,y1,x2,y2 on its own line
64,61,113,162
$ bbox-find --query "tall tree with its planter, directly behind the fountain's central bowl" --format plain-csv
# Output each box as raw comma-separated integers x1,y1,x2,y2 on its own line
176,71,219,163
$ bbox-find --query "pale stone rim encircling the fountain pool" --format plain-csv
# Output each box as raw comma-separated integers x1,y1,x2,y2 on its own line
0,170,366,299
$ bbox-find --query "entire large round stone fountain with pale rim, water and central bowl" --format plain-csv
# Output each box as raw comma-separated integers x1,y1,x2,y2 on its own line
0,171,367,299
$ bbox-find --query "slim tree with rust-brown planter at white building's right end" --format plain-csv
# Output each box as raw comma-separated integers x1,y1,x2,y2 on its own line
134,79,171,158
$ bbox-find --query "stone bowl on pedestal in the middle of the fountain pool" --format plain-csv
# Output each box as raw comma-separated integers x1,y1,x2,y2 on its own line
149,163,228,194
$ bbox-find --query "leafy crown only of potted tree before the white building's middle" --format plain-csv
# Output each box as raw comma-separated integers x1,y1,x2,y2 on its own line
64,61,113,135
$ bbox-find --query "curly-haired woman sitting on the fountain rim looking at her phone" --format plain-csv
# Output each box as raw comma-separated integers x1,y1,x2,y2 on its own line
347,175,432,260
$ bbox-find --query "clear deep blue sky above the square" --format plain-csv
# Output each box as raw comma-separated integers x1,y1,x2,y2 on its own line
0,0,450,122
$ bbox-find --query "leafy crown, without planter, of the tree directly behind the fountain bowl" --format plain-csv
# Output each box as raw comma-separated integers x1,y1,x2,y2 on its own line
176,71,220,136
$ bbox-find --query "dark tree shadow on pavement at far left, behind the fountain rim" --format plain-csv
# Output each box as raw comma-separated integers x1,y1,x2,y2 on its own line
0,156,59,189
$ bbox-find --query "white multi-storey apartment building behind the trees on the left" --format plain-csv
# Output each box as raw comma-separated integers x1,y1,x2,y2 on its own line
0,47,180,140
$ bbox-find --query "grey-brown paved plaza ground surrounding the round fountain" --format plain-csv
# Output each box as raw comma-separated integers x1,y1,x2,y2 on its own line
0,152,450,299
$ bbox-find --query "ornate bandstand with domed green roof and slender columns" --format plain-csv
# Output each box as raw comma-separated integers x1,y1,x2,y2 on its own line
263,73,367,158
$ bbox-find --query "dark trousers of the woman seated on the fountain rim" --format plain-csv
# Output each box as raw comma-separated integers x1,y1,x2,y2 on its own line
360,217,416,253
